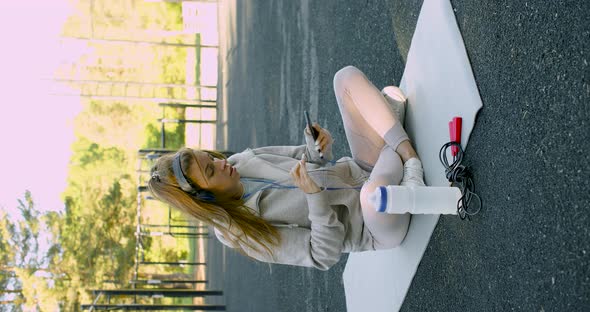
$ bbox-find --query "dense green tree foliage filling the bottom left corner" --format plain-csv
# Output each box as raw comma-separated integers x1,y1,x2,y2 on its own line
0,179,135,311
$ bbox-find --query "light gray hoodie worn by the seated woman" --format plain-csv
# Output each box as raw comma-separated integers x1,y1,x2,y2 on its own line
215,130,374,270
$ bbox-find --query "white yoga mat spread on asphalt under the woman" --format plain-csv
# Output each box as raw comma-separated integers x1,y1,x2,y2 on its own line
343,0,482,312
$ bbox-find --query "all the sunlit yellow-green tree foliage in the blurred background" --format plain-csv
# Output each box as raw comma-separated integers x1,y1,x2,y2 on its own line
0,0,197,311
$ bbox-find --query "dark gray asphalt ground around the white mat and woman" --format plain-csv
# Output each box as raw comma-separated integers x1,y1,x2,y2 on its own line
210,0,590,311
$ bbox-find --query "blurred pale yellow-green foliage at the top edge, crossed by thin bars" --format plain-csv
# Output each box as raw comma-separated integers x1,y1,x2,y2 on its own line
58,0,188,86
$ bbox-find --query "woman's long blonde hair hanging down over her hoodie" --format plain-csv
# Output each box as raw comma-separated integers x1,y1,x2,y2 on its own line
148,148,280,256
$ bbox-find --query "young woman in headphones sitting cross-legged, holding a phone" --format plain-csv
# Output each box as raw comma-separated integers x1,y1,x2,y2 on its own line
148,66,424,270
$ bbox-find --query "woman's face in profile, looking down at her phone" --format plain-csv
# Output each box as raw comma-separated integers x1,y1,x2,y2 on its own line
186,150,243,198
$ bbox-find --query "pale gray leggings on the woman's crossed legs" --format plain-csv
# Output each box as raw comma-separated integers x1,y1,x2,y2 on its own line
334,66,411,249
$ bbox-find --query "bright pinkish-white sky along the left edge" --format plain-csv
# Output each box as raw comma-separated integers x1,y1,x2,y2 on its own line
0,0,81,212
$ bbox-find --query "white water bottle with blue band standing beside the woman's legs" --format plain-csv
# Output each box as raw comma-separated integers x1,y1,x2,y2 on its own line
369,185,461,214
